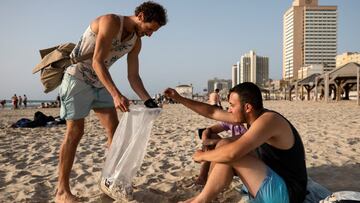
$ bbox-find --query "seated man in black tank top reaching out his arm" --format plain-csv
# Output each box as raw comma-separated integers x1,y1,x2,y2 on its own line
165,82,307,203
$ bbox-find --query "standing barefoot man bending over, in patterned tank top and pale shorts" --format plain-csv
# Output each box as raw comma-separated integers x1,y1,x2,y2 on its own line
55,1,167,202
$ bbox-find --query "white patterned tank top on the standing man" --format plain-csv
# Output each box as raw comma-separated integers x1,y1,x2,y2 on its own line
66,15,137,88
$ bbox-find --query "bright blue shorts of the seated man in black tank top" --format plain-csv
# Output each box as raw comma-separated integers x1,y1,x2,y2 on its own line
249,167,290,203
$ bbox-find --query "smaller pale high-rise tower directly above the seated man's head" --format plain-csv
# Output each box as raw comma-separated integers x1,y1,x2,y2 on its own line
238,50,269,86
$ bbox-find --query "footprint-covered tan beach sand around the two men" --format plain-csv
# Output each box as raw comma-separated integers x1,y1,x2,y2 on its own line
0,101,360,202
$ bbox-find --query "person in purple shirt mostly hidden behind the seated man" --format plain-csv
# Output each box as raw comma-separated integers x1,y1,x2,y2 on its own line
195,122,247,185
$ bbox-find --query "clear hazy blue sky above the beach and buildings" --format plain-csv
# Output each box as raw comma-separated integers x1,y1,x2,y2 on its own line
0,0,360,100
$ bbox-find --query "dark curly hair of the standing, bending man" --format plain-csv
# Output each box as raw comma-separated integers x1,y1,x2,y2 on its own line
135,1,167,26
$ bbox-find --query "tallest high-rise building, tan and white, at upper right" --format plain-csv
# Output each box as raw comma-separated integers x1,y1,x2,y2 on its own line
283,0,337,80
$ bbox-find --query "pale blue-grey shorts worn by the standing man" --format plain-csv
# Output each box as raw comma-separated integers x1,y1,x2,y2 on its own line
59,73,114,120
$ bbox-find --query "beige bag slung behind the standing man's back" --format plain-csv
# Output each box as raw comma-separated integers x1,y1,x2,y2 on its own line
32,43,93,93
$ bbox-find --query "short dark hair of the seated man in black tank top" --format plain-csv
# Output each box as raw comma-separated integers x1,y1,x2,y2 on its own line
229,82,264,110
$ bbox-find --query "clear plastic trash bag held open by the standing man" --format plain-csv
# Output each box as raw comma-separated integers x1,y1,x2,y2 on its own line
100,105,161,200
